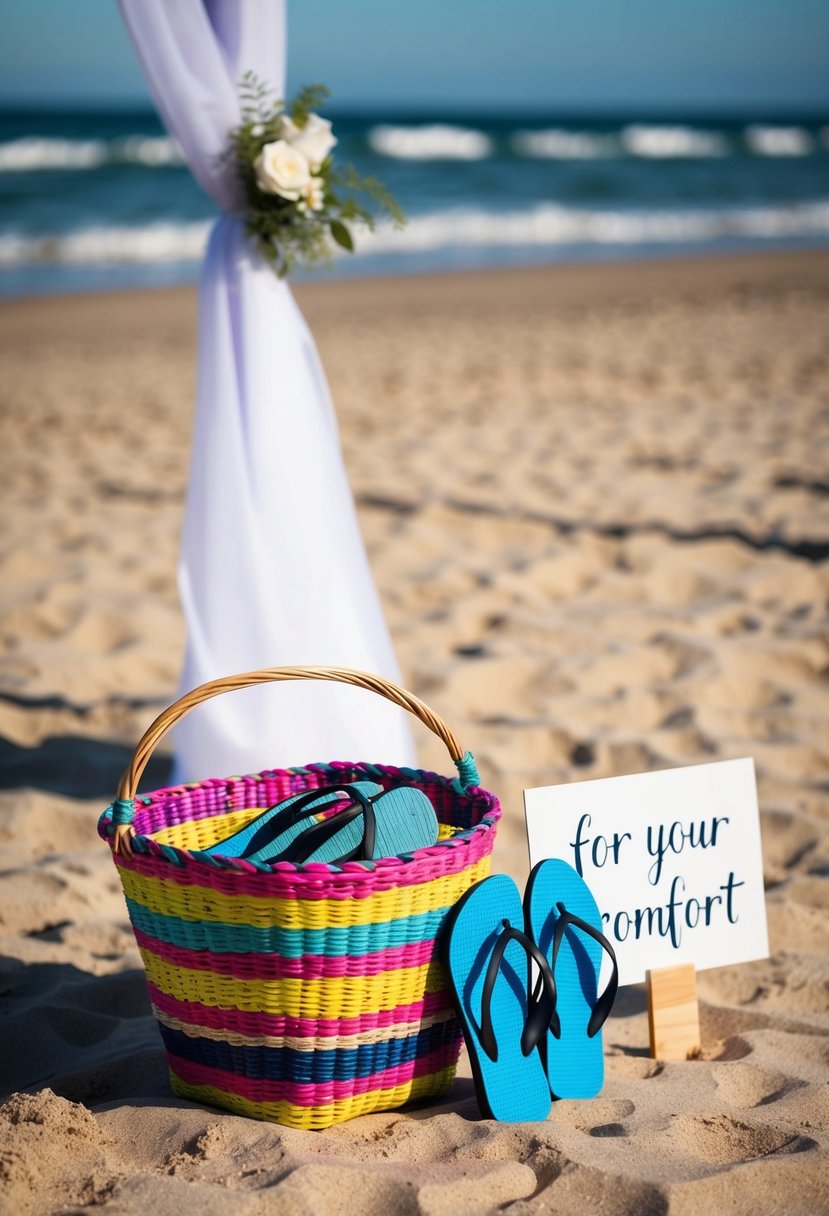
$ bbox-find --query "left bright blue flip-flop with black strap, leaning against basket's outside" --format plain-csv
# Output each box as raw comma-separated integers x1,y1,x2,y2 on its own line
442,874,554,1124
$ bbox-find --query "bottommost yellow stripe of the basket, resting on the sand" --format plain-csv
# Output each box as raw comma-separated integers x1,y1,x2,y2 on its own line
170,1065,455,1131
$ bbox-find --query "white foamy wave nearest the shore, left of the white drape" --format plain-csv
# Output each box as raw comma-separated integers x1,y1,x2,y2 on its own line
0,221,210,268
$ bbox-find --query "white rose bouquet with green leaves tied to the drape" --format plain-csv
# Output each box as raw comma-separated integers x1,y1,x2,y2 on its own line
229,73,404,276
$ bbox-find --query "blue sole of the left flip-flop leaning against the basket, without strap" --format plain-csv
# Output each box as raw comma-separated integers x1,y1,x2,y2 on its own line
442,874,551,1122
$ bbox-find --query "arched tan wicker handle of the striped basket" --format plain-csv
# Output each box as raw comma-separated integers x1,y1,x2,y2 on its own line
112,666,480,855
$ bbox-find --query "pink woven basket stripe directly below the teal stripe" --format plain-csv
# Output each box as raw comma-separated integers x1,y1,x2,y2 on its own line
135,929,434,980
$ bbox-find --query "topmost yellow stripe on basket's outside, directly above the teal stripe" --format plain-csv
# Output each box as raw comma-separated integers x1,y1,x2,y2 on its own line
119,856,490,929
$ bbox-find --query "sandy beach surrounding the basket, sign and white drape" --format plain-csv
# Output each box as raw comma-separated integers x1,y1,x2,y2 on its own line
0,253,829,1216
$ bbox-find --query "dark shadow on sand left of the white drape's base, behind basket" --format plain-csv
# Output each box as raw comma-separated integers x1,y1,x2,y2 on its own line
0,734,173,804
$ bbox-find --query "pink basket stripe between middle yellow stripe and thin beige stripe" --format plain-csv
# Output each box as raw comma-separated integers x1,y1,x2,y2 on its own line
147,984,450,1038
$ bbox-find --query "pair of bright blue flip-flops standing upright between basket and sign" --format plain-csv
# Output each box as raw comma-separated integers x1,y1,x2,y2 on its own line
442,860,619,1122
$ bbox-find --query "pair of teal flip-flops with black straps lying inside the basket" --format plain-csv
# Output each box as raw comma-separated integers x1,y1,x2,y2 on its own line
204,781,438,866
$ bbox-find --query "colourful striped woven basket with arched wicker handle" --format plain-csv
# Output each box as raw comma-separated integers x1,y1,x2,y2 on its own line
98,668,501,1128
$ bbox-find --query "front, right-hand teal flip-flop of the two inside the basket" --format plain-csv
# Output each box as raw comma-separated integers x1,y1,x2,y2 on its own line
246,782,438,866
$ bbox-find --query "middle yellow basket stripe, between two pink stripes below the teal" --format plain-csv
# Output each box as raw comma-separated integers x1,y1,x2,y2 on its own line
141,950,446,1018
